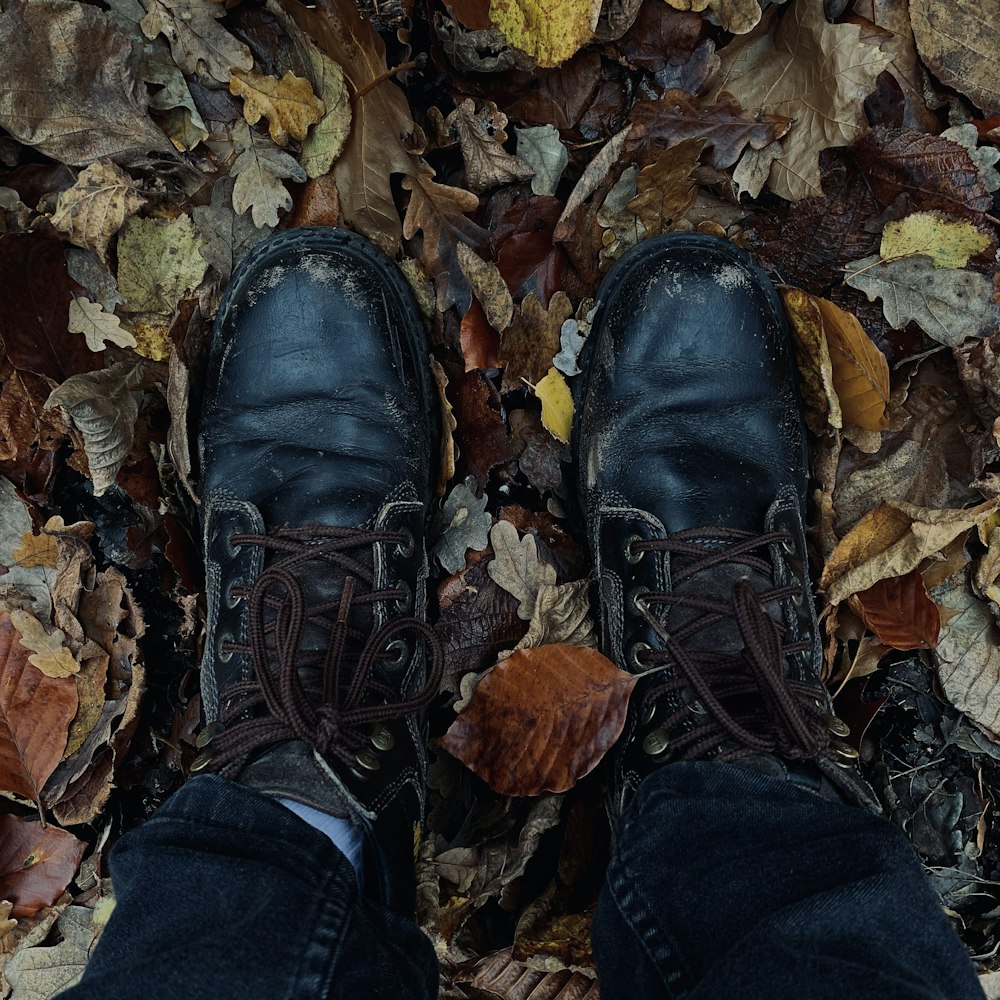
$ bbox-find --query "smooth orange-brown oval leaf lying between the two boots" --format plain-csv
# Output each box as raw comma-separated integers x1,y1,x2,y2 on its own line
440,645,638,795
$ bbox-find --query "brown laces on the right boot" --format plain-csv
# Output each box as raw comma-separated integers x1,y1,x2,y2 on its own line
632,528,830,760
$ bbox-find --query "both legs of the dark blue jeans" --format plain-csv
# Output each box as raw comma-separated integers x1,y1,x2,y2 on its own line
63,763,982,1000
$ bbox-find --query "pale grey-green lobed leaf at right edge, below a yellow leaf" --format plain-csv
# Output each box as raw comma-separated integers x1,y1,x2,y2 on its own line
844,254,1000,347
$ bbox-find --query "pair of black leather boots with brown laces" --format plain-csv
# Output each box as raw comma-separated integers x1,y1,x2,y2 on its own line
192,229,877,912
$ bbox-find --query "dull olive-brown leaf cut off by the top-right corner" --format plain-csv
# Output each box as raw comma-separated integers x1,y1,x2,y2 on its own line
910,0,1000,114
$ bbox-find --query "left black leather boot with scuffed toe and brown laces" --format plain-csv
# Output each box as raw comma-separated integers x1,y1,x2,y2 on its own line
191,229,441,912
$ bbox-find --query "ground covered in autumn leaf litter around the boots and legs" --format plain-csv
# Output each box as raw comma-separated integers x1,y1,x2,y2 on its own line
0,0,1000,998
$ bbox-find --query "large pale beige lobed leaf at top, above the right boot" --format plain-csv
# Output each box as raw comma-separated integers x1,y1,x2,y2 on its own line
714,3,890,201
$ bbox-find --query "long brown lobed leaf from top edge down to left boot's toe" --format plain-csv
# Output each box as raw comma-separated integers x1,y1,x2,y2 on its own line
282,0,417,254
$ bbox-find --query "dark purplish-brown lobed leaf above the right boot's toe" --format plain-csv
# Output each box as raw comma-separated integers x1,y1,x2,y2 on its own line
627,89,788,170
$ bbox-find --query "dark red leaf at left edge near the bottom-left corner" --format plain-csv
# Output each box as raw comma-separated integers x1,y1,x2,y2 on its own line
0,814,87,916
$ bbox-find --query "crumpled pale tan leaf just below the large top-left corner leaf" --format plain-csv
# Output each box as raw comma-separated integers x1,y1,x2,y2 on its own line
52,160,145,263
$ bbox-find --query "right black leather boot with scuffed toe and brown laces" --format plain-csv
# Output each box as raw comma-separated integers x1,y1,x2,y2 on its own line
574,234,877,813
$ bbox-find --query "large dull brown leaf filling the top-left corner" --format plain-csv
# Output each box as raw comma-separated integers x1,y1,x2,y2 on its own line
0,0,173,165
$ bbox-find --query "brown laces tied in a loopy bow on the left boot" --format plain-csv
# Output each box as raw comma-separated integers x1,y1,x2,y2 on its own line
209,526,444,770
